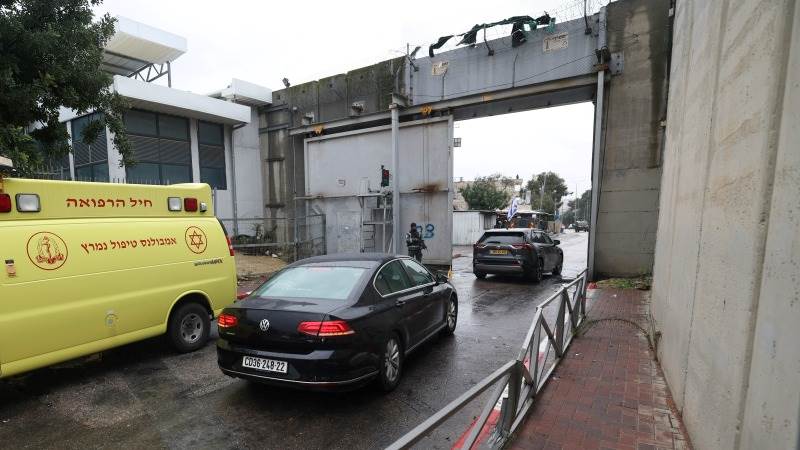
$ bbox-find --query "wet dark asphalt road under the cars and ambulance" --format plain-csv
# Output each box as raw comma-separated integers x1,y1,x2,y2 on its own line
0,232,587,449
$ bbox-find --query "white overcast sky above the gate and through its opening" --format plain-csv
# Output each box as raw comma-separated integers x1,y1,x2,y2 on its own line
97,0,597,195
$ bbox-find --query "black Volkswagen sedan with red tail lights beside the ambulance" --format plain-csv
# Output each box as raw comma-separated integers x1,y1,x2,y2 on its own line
217,253,458,391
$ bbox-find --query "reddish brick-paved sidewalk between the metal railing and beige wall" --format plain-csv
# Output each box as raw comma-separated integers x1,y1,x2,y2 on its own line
509,289,691,450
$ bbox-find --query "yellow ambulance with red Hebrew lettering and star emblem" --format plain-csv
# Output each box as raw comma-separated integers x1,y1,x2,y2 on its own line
0,178,236,378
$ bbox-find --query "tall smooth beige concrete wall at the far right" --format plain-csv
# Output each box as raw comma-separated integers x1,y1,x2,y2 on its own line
652,0,800,449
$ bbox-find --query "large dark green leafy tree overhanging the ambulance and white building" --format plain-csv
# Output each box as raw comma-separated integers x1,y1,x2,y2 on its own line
0,0,133,175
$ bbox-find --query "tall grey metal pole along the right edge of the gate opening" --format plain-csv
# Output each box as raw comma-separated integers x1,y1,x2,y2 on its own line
587,7,606,280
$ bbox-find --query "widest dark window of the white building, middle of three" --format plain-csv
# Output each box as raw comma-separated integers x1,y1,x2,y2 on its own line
125,110,192,184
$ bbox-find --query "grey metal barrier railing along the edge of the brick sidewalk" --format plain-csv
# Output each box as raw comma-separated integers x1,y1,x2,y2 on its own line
387,269,587,450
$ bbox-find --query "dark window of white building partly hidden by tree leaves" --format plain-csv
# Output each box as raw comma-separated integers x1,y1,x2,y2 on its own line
71,113,109,181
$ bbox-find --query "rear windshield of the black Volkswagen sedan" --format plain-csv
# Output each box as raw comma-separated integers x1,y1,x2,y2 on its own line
252,266,366,300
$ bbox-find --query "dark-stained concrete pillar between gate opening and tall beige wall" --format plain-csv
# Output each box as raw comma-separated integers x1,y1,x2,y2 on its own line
594,0,669,277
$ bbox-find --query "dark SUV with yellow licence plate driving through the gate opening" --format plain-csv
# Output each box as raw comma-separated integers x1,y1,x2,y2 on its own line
472,228,564,282
